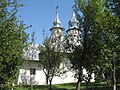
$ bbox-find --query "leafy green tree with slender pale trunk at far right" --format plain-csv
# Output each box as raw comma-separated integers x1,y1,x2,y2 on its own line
97,11,120,90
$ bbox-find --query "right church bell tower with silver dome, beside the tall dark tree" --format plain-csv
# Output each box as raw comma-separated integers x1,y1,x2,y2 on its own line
66,11,81,46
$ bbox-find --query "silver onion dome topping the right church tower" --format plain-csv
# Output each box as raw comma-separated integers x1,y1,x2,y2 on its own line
69,11,79,28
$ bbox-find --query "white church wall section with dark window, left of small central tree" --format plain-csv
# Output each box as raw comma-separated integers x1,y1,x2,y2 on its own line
18,62,45,85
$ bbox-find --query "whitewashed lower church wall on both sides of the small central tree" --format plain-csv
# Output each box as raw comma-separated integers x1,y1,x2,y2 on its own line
18,62,79,85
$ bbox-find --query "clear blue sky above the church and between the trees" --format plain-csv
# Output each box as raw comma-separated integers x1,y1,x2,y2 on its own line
18,0,74,44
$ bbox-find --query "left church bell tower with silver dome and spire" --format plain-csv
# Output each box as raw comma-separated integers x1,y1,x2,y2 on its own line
50,6,64,48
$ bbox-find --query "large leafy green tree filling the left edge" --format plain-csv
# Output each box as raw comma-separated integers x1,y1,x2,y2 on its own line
0,0,27,89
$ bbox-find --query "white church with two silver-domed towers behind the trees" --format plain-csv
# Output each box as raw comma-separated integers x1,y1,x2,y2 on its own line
17,8,94,85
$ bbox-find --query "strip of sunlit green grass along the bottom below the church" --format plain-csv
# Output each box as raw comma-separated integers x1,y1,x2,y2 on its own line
14,83,120,90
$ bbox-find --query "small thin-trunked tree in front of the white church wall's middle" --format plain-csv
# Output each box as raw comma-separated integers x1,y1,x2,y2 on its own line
39,39,65,90
